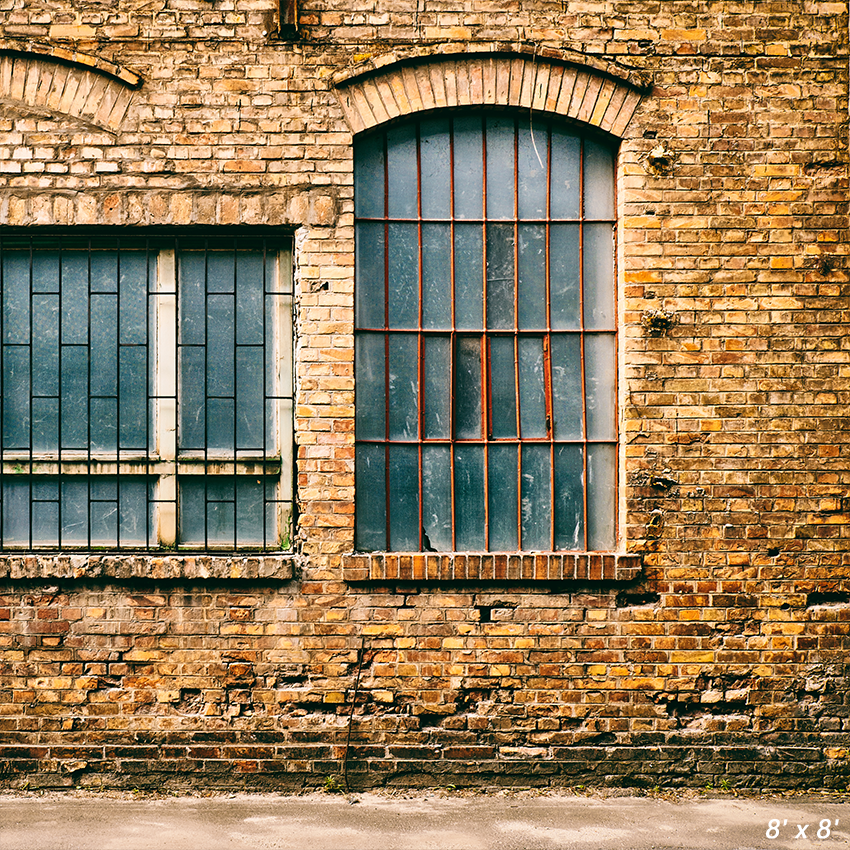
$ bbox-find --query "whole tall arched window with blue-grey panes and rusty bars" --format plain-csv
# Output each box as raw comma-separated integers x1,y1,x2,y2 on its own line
355,112,618,551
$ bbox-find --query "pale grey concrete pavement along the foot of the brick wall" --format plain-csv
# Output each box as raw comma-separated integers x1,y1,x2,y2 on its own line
0,791,850,850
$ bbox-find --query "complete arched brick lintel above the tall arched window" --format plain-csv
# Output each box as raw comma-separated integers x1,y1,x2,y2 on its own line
336,54,641,137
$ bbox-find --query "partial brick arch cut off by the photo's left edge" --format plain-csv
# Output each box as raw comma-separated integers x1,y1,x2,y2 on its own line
0,45,141,132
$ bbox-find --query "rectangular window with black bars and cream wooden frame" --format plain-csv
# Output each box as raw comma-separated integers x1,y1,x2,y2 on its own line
0,229,293,551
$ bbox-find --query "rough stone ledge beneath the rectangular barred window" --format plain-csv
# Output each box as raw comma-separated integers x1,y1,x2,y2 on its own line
0,553,295,581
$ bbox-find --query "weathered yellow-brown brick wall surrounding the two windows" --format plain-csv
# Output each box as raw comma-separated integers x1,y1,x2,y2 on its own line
0,0,850,788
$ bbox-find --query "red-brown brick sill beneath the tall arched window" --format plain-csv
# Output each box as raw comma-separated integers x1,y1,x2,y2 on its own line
342,552,642,582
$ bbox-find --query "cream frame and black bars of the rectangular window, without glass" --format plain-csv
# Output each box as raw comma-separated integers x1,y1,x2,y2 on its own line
0,226,295,554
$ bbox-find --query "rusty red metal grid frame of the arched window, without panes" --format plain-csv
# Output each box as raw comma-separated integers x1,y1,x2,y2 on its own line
355,108,622,553
